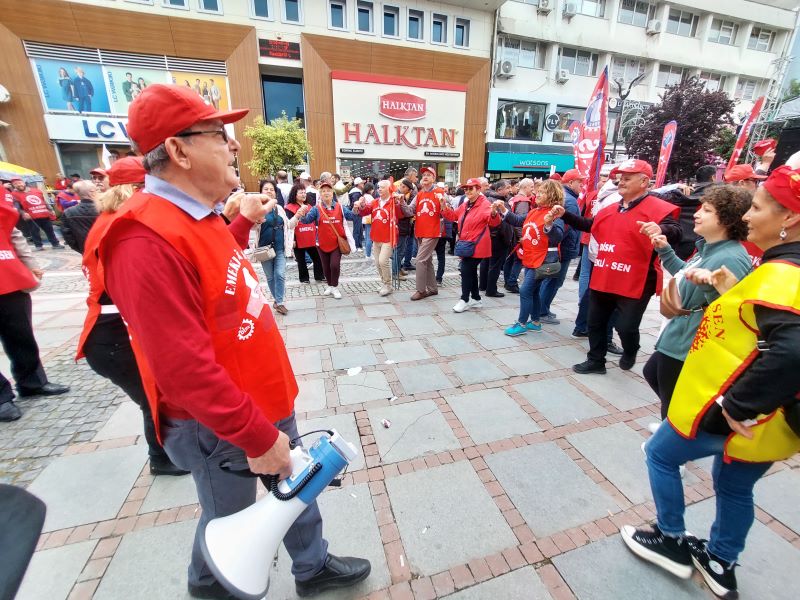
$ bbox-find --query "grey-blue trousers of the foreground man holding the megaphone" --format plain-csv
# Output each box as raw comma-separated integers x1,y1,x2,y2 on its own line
161,413,328,586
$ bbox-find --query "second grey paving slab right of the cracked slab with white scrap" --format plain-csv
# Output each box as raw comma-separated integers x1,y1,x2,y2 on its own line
512,380,608,427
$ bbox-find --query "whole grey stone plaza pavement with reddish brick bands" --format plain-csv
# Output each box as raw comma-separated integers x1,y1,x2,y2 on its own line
0,251,800,600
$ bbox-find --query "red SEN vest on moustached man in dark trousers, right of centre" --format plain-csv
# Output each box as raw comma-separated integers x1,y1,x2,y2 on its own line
589,196,680,298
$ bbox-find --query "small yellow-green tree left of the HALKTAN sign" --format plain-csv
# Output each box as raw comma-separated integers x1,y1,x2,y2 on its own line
244,111,311,178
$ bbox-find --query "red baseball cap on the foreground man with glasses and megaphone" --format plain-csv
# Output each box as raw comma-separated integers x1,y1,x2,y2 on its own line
128,83,249,153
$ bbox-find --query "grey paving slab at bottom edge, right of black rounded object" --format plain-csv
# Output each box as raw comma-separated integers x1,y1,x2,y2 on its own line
16,540,97,600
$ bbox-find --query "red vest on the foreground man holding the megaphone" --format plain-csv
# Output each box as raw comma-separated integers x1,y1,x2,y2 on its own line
99,192,297,438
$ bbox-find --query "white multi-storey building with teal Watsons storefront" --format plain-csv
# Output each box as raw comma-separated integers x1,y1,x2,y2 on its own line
486,0,797,175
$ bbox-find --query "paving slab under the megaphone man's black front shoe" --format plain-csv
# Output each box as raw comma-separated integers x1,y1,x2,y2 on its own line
267,484,392,600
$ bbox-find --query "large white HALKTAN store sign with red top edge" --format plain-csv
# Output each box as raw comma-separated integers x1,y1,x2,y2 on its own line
331,71,467,161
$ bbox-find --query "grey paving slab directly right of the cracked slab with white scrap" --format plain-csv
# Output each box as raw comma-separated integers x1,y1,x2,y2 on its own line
447,389,540,444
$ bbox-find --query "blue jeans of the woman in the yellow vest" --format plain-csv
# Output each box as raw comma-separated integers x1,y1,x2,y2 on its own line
645,421,772,562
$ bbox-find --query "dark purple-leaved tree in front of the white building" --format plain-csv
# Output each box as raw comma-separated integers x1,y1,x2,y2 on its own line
628,77,734,181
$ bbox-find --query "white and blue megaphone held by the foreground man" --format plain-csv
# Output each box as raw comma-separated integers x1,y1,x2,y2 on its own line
200,430,357,600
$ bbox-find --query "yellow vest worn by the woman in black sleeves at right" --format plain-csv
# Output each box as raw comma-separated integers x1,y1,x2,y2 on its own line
667,261,800,462
